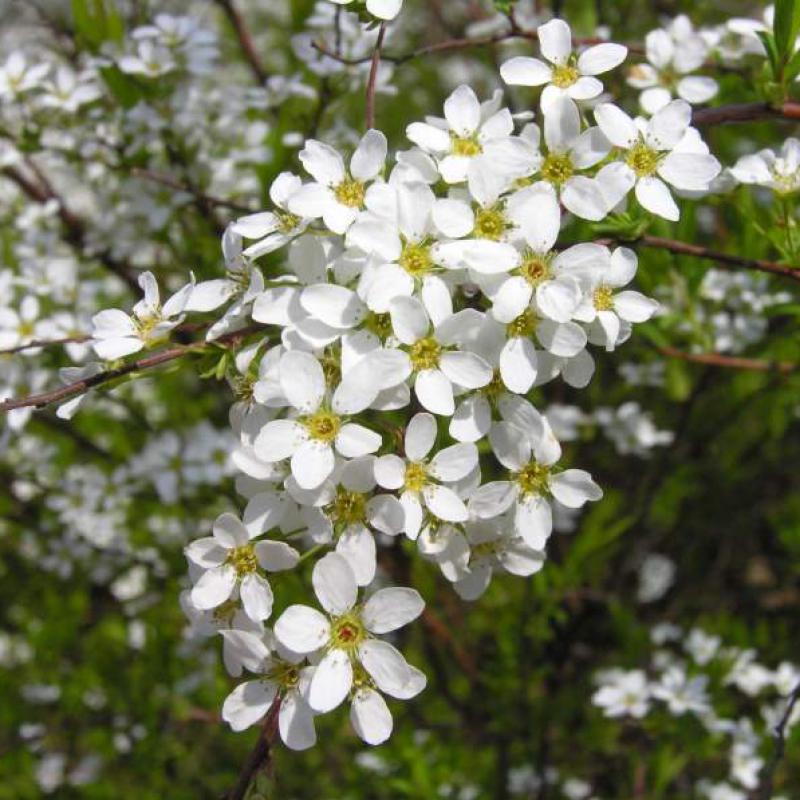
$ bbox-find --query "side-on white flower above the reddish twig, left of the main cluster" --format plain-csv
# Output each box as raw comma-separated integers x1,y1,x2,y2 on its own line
92,272,193,361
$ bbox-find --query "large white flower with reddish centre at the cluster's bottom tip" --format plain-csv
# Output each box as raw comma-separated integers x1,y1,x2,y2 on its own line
275,553,425,744
